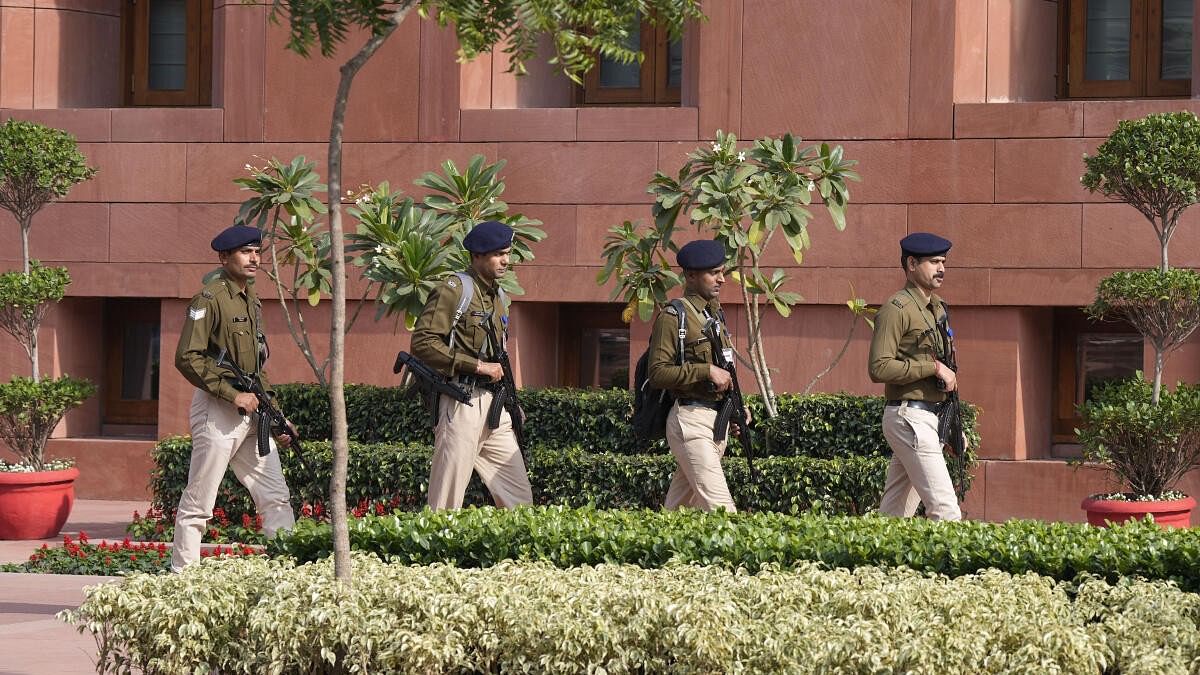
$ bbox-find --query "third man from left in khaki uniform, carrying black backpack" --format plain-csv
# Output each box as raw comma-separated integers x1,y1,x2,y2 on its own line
647,240,737,512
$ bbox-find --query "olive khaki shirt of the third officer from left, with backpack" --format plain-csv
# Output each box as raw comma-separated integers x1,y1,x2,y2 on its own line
646,293,725,401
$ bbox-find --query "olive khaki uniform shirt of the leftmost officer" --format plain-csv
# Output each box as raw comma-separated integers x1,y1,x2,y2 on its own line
175,273,274,402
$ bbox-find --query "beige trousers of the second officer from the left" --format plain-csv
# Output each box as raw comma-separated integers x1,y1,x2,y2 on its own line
428,387,533,510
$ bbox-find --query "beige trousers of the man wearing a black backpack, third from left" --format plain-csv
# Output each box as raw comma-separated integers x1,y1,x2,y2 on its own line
664,402,738,513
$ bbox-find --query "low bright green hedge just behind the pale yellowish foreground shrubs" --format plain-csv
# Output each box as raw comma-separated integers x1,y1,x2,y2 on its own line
268,507,1200,592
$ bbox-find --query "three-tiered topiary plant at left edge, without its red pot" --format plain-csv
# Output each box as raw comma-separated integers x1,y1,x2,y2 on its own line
0,119,96,471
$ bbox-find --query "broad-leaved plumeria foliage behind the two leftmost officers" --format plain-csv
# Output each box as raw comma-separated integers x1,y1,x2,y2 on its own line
234,155,546,386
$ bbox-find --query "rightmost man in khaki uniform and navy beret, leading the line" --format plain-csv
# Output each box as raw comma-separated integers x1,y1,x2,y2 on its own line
868,232,962,520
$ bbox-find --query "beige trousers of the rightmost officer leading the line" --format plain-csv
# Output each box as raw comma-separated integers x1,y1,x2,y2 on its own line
880,404,962,520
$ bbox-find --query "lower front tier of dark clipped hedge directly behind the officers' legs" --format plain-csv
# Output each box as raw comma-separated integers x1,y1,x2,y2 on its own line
151,436,887,530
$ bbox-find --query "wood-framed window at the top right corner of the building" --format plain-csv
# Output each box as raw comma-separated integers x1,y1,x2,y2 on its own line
1058,0,1195,98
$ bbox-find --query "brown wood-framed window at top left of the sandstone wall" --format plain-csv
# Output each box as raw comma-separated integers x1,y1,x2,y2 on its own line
121,0,212,106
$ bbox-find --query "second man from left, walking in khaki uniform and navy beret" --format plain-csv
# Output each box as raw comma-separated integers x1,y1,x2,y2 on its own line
412,221,533,509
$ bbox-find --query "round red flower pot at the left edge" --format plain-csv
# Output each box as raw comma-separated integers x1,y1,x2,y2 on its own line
0,466,79,539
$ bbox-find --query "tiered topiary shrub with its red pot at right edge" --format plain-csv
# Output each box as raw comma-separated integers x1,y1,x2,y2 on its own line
1079,112,1200,526
